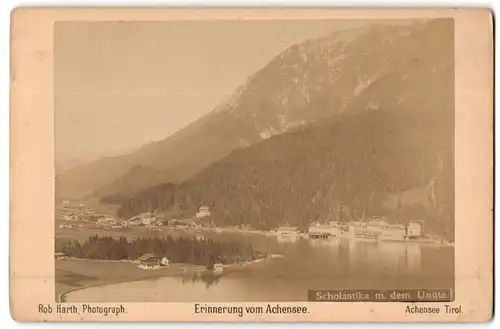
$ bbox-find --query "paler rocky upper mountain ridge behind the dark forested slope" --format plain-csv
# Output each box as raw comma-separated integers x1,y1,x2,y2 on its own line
56,19,453,200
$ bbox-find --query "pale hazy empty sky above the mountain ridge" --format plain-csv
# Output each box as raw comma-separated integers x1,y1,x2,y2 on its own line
55,20,388,158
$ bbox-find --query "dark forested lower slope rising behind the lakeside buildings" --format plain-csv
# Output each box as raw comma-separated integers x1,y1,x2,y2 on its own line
118,105,454,236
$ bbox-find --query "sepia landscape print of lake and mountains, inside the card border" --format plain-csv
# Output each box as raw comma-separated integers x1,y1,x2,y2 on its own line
53,18,458,305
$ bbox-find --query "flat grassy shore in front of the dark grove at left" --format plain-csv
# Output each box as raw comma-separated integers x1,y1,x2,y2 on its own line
55,260,204,301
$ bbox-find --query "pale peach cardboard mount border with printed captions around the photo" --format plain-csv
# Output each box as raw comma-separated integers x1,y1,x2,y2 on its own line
10,8,493,322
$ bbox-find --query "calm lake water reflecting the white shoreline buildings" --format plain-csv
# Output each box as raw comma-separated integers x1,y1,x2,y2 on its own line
66,234,454,302
